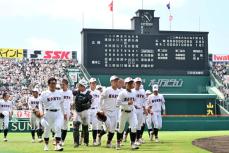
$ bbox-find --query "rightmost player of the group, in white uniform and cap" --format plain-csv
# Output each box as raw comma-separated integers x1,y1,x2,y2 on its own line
148,85,165,142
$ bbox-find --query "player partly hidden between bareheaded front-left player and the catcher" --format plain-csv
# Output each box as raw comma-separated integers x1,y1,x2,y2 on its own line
61,79,73,145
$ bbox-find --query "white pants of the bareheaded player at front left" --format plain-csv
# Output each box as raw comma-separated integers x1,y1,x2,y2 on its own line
44,111,64,138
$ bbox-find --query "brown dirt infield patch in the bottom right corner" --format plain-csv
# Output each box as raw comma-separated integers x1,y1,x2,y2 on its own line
192,136,229,153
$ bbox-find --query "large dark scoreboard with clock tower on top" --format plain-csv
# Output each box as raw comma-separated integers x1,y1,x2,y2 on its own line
82,10,209,76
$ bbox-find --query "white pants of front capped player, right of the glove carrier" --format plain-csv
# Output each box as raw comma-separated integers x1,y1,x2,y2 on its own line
118,110,138,133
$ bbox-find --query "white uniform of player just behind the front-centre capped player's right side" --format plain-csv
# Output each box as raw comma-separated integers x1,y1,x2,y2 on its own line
132,89,146,130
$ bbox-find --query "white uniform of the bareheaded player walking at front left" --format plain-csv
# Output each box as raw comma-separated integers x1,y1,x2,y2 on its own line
39,90,67,138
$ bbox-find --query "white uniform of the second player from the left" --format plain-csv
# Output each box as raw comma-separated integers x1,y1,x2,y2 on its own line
28,96,40,130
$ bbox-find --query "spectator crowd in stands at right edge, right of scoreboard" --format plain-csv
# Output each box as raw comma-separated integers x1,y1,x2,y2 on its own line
212,63,229,99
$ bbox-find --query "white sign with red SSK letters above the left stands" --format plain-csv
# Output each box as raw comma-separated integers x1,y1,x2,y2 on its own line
44,51,70,60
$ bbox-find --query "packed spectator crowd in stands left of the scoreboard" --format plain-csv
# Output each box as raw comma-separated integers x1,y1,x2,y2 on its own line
0,59,77,110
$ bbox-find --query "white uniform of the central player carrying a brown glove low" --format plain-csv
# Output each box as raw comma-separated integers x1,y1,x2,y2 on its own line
100,87,119,133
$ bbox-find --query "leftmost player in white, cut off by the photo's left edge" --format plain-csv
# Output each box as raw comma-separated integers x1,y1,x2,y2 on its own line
0,93,13,142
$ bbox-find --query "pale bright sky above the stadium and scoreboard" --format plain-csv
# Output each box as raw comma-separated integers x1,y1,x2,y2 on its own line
0,0,229,54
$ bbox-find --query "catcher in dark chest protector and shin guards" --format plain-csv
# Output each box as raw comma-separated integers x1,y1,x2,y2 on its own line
73,80,92,147
